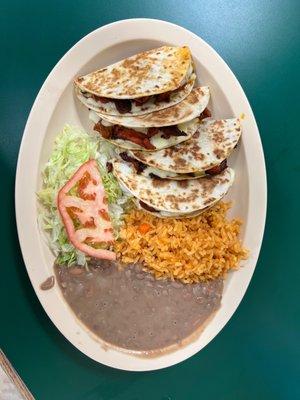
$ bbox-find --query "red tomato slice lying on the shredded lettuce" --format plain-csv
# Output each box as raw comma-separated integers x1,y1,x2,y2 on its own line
57,160,116,260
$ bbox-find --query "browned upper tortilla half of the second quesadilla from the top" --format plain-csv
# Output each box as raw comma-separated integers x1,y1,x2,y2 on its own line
92,86,210,128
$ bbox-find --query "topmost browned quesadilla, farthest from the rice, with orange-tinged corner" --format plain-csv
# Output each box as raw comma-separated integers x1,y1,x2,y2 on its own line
74,46,196,116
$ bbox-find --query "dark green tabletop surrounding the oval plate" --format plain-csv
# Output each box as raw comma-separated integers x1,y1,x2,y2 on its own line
0,0,300,400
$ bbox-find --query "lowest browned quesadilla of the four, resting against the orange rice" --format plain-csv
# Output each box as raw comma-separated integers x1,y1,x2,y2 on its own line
113,161,234,214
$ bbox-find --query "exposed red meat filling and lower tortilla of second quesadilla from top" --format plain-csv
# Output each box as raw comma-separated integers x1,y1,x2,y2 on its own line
90,111,199,151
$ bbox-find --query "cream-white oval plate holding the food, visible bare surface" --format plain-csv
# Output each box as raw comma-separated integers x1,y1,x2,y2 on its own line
15,19,266,371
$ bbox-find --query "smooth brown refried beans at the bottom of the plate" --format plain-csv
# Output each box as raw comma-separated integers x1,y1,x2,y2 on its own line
55,261,223,352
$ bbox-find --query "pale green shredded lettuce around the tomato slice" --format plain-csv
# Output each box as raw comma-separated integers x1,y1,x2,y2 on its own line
37,125,128,265
